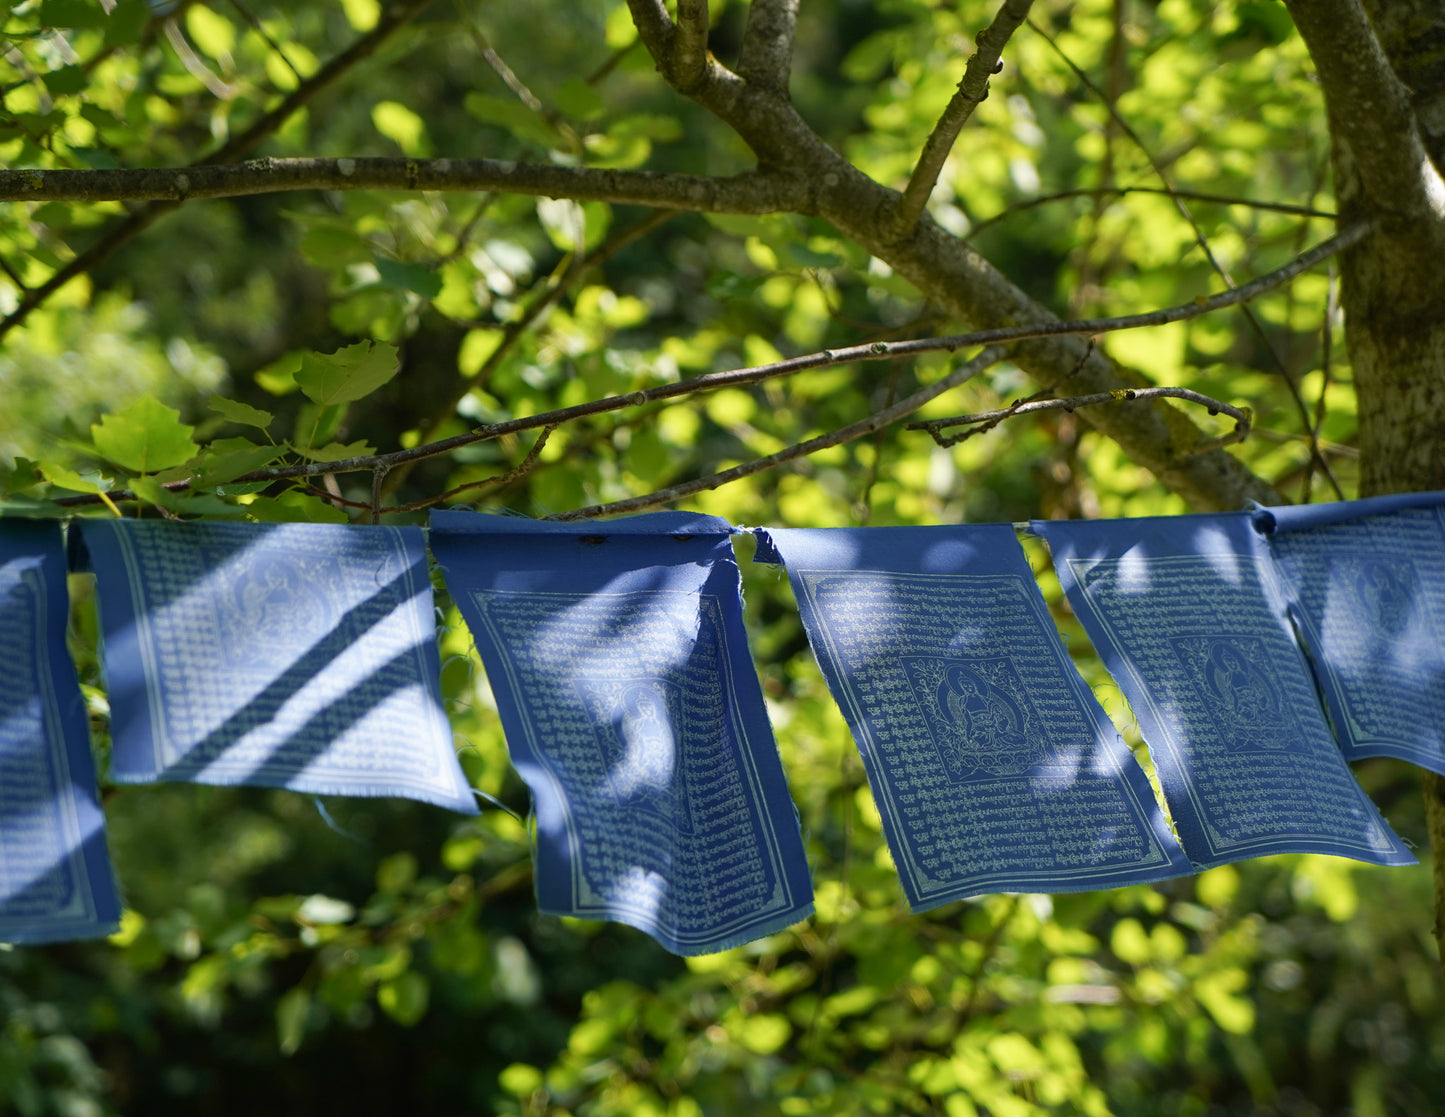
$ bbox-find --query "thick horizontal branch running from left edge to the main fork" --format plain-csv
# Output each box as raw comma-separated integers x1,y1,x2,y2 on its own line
0,158,809,214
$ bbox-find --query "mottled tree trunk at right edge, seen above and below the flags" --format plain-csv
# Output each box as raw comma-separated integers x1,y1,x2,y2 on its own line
1289,0,1445,975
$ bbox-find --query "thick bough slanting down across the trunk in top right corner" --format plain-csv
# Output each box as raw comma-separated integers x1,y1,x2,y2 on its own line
1286,0,1445,218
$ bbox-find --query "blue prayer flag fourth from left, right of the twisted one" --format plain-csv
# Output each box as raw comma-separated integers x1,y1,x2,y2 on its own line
757,525,1191,912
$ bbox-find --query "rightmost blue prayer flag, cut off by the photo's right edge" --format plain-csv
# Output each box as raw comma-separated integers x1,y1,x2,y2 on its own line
1254,493,1445,775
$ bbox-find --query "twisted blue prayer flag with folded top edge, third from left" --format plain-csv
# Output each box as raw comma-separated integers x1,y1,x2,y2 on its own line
431,512,812,955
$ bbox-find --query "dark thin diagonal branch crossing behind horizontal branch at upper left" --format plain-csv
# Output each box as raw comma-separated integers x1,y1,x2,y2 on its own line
0,0,432,338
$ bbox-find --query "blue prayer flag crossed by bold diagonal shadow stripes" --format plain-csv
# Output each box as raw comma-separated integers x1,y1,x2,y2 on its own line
77,520,477,814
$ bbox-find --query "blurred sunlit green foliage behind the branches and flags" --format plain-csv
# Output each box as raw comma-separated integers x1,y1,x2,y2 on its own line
0,0,1445,1117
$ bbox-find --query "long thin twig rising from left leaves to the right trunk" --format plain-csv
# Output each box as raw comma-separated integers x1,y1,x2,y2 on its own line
55,228,1376,506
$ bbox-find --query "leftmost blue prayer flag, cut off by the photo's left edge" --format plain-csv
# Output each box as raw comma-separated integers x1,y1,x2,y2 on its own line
0,520,120,942
